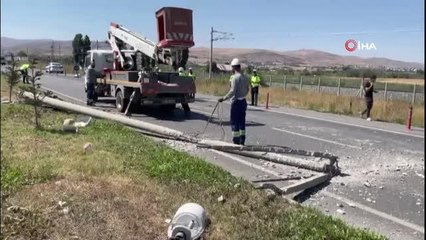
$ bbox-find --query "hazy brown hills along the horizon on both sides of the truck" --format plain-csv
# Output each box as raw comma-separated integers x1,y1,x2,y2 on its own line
1,37,424,69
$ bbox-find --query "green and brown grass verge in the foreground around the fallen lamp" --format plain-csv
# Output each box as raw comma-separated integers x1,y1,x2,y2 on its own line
1,104,385,240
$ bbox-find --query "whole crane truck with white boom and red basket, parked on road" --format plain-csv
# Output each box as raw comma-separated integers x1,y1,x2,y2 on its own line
84,7,196,113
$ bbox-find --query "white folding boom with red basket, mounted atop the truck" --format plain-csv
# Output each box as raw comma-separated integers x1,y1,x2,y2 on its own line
108,7,194,71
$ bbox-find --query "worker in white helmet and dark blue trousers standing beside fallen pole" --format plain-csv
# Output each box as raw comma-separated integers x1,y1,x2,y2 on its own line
218,58,250,145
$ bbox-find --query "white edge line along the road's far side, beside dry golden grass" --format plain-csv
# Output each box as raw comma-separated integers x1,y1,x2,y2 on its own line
198,99,425,139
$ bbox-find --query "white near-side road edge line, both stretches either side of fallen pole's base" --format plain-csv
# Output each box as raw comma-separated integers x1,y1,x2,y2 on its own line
212,150,424,234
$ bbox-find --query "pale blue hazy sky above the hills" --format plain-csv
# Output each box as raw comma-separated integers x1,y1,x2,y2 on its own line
1,0,424,63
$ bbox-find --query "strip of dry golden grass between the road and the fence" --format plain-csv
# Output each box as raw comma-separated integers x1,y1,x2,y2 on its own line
196,80,424,127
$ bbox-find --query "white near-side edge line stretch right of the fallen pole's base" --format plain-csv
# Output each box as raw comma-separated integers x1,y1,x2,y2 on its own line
320,191,425,234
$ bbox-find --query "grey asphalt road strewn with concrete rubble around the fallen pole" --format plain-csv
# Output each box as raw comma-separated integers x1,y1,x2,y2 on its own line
42,75,424,240
